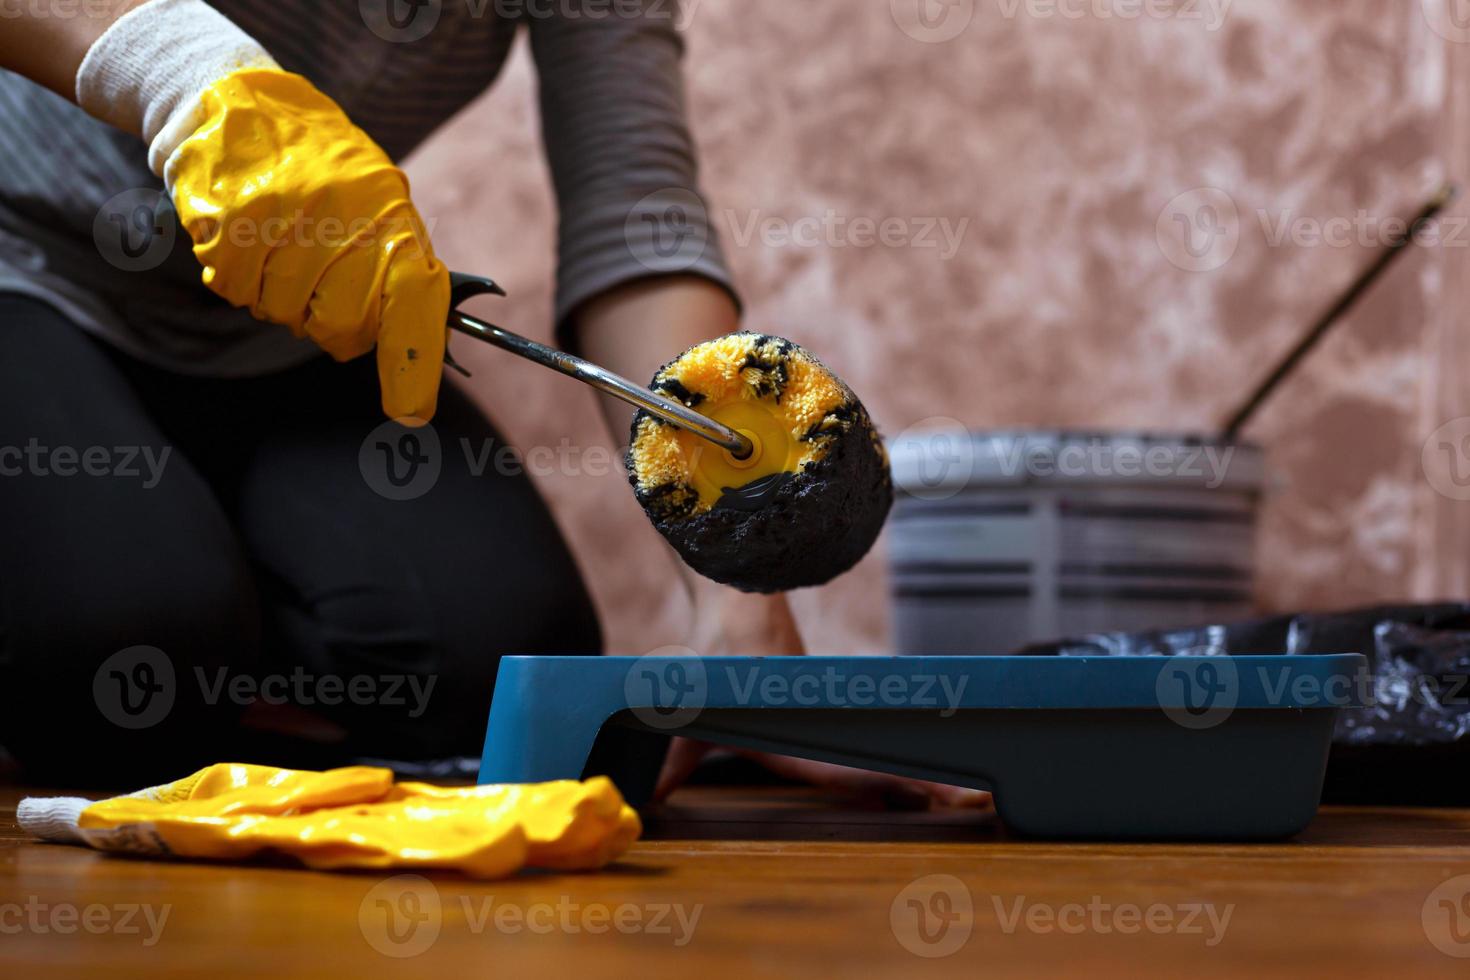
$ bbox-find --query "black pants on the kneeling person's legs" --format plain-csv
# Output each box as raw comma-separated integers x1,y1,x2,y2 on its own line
0,295,601,786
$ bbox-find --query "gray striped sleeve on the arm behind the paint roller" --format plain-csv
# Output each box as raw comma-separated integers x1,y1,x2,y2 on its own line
523,0,735,342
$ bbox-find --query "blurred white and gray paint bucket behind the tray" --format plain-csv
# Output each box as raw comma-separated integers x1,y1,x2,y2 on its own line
888,423,1266,654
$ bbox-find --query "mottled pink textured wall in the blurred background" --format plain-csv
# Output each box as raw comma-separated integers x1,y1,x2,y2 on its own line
410,0,1470,652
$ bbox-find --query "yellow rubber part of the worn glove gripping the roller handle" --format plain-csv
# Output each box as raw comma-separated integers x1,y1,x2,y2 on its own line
163,68,450,422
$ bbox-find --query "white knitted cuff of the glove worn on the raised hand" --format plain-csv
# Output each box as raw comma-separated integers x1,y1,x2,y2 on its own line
76,0,281,176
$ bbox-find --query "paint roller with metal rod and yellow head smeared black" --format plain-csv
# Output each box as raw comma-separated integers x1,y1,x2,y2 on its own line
445,273,894,592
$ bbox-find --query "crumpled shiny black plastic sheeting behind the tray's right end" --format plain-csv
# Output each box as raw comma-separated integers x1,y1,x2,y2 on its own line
1020,602,1470,805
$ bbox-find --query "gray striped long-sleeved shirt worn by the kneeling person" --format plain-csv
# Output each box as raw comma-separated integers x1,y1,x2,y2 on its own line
0,0,729,376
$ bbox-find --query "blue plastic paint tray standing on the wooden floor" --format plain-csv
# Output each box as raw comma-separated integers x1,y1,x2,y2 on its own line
479,654,1367,840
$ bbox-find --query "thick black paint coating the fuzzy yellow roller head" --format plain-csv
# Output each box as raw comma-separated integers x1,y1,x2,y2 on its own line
629,333,894,592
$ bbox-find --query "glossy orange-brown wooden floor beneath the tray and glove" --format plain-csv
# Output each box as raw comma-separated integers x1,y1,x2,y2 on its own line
0,788,1470,980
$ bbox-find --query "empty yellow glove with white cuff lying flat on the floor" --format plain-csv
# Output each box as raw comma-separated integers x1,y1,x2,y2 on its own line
16,763,641,879
